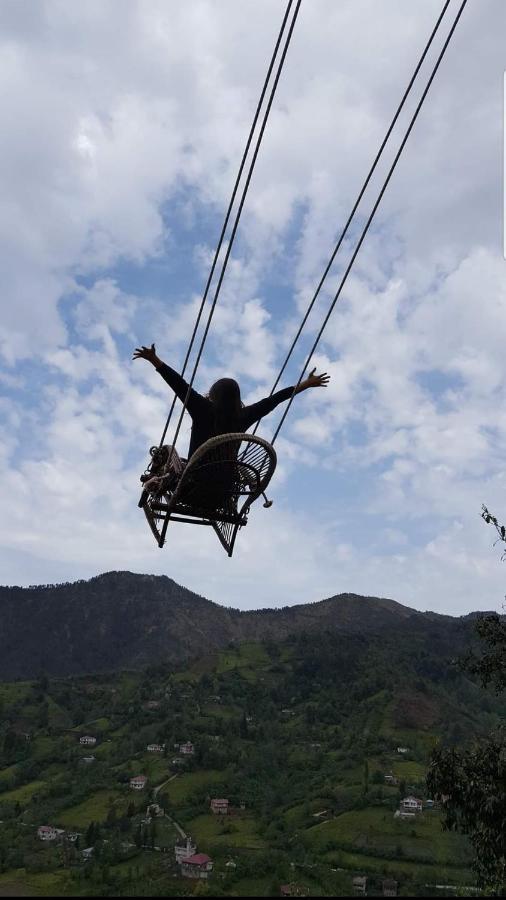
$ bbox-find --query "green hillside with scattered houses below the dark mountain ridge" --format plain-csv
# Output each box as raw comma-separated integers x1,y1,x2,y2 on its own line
0,629,501,896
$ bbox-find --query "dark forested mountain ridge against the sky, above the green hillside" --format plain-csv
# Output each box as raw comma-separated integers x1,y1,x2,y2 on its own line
0,572,482,680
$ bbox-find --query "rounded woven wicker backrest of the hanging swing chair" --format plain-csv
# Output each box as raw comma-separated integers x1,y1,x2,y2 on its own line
174,432,276,517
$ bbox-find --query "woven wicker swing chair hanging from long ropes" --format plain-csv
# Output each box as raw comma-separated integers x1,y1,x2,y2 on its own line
139,432,276,556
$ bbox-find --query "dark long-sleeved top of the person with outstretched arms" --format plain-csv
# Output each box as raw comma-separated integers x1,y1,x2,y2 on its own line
157,363,293,458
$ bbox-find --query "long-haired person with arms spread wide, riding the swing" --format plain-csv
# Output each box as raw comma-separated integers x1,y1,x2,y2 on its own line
132,344,330,490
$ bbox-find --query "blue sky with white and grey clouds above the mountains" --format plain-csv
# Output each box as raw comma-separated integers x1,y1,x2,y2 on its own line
0,0,506,614
